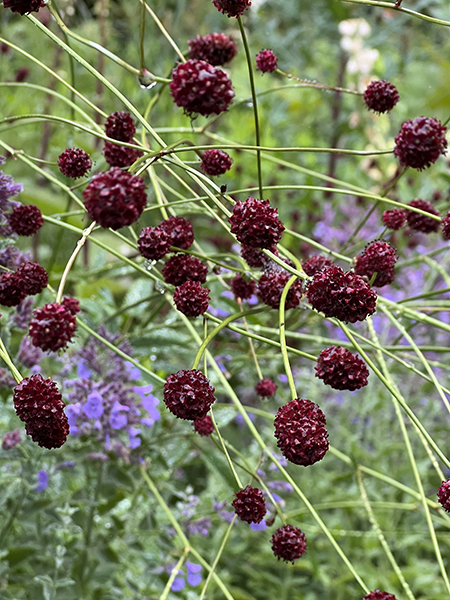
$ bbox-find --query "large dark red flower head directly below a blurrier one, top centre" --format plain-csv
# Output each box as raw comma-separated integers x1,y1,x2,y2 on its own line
169,59,234,117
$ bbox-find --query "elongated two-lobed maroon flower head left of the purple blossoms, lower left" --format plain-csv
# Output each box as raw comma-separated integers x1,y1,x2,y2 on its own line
14,374,69,449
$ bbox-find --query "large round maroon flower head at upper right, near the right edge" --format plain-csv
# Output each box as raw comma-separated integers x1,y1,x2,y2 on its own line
394,117,447,171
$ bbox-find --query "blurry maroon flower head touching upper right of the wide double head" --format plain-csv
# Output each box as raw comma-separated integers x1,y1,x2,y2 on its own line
355,240,397,287
